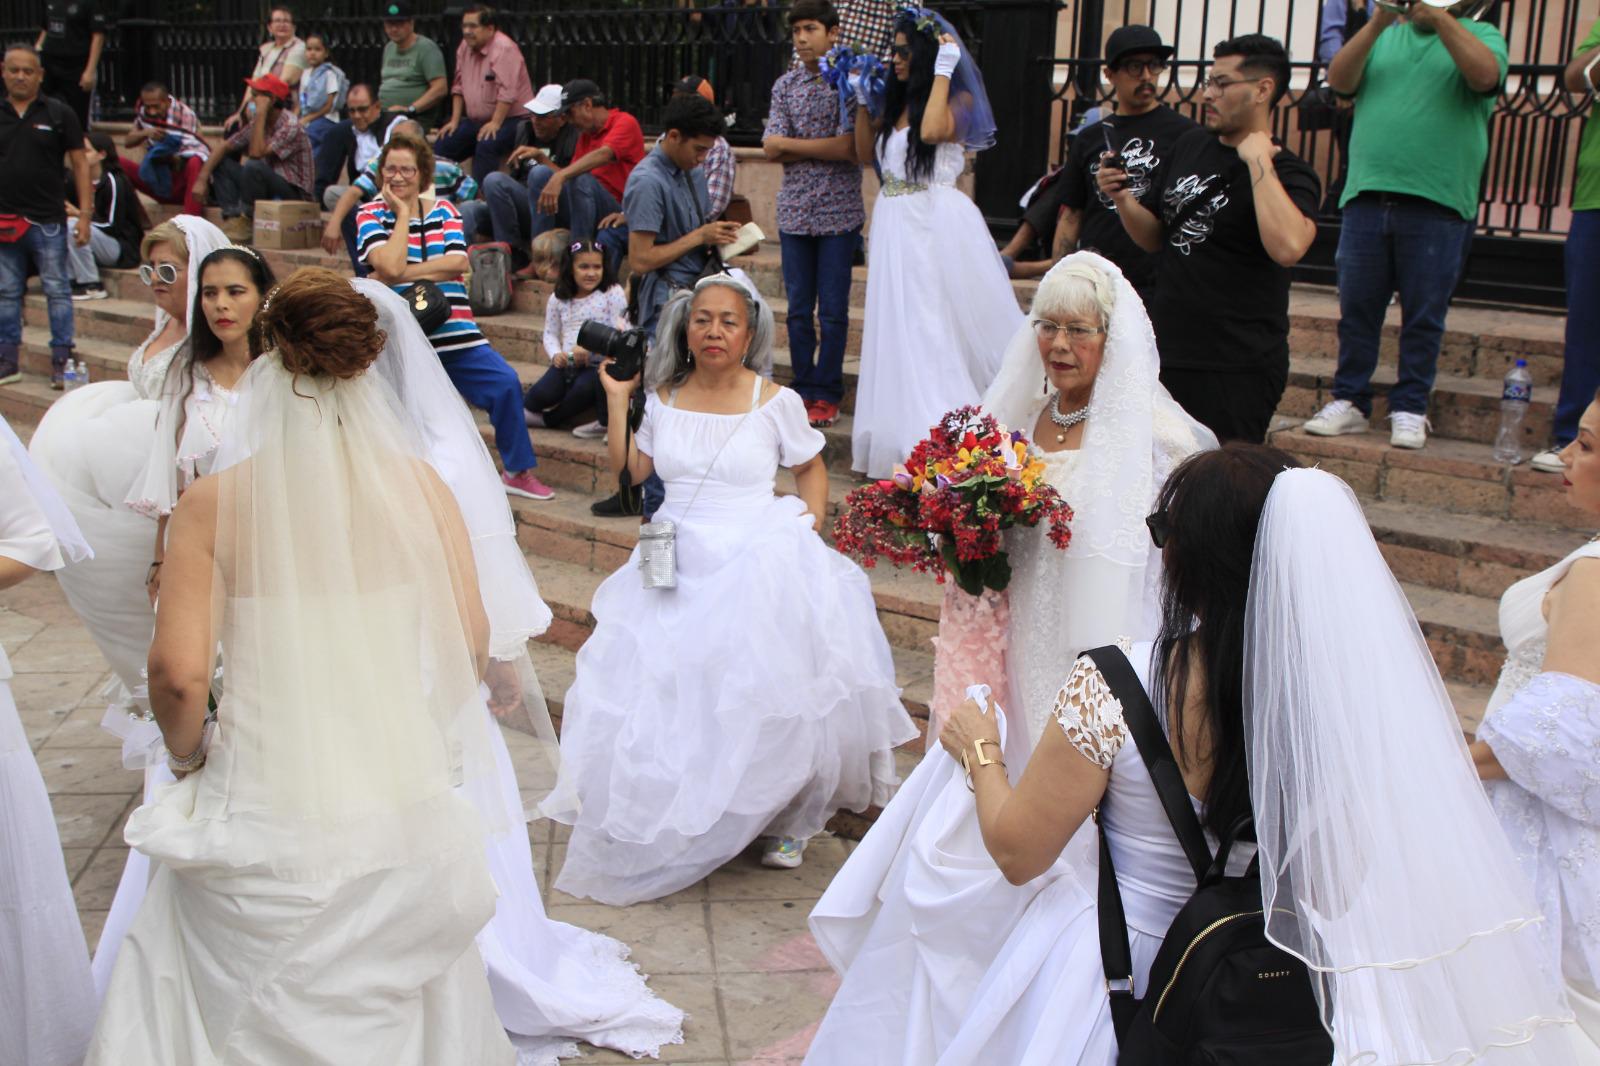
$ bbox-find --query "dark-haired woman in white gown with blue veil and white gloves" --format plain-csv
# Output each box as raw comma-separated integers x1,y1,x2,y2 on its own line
851,8,1022,477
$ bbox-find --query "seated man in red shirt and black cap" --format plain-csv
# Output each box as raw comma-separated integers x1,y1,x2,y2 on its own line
528,78,645,240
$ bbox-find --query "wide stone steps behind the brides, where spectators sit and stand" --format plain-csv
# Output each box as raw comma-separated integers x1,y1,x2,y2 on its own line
0,201,1594,749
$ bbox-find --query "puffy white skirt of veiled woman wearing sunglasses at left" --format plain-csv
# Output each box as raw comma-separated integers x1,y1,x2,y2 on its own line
27,381,160,710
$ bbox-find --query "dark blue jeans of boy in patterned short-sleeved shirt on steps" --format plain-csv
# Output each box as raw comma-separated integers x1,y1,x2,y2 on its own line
778,229,861,403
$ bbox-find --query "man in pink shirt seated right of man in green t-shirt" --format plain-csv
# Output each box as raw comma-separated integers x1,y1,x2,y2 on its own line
434,3,533,182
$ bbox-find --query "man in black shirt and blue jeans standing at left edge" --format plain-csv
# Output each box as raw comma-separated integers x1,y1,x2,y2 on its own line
0,45,94,389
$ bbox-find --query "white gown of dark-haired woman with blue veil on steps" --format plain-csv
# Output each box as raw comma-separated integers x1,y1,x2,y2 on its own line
851,130,1022,477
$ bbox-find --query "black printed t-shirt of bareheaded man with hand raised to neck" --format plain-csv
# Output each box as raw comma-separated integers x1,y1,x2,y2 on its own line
1142,130,1322,371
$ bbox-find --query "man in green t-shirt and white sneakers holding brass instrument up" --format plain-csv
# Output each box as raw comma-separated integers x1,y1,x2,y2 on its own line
1306,0,1507,448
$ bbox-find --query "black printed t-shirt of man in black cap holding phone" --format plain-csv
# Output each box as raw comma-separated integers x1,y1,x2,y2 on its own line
1061,106,1195,301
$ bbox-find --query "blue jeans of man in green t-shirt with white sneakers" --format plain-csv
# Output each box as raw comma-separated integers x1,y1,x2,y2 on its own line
1333,195,1472,418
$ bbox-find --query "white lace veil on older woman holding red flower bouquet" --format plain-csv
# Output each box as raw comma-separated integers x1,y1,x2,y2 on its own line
982,251,1216,741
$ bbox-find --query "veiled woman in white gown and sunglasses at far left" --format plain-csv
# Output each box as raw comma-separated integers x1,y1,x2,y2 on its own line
29,214,229,723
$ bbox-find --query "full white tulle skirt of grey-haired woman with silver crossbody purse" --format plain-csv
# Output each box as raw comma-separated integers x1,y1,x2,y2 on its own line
555,496,917,906
